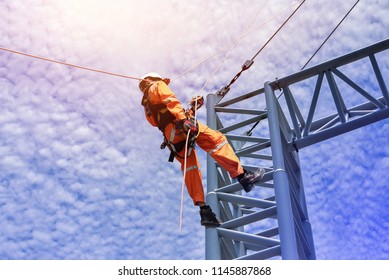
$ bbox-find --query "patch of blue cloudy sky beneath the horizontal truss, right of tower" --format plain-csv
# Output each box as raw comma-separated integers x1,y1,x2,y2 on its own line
301,117,389,259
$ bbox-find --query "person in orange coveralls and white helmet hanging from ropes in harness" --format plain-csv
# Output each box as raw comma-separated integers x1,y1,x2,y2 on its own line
139,72,265,227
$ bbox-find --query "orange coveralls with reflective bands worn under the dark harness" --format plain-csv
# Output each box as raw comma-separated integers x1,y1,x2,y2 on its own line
145,81,243,205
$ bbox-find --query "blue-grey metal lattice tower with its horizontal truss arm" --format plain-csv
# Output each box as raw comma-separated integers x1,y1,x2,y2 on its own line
206,39,389,259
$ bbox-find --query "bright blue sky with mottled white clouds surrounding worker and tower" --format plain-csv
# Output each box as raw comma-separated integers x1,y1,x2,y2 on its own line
0,0,389,260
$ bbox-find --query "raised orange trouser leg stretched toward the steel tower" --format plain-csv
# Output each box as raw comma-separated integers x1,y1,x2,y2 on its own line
196,123,243,178
